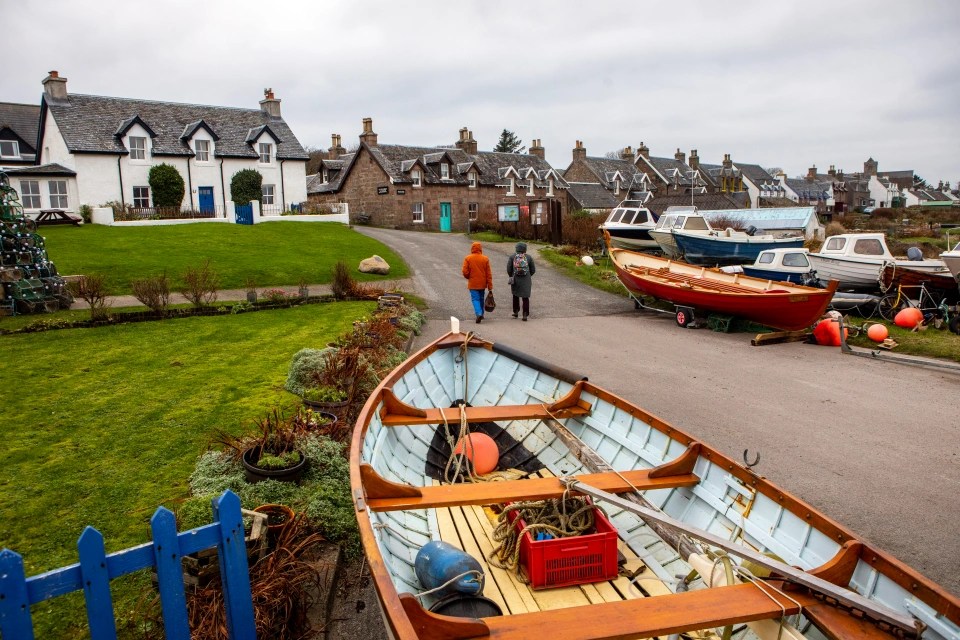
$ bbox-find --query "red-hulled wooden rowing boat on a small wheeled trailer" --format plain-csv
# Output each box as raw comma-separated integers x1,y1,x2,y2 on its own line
609,238,837,331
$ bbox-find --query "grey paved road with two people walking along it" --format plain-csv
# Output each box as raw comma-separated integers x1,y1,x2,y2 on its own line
359,228,960,594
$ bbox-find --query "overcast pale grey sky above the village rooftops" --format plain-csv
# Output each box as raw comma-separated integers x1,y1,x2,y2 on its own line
7,0,960,184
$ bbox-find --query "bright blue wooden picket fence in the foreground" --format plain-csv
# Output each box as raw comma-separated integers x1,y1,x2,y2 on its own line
0,491,257,640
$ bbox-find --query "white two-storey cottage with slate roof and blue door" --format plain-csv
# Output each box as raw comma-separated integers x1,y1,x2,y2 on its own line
11,71,308,217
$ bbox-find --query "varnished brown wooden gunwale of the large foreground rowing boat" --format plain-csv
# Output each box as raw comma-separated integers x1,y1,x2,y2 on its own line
350,333,960,640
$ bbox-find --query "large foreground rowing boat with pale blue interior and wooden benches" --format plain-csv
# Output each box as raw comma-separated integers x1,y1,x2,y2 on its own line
350,326,960,640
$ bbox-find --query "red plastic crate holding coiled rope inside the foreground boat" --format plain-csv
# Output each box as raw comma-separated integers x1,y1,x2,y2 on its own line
507,500,619,589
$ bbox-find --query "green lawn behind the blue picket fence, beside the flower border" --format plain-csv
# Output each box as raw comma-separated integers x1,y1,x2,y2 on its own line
0,302,376,638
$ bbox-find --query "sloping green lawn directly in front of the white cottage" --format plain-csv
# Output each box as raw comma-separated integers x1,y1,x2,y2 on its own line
40,222,409,295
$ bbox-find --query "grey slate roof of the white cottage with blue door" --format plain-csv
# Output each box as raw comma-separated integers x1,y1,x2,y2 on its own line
42,94,309,160
